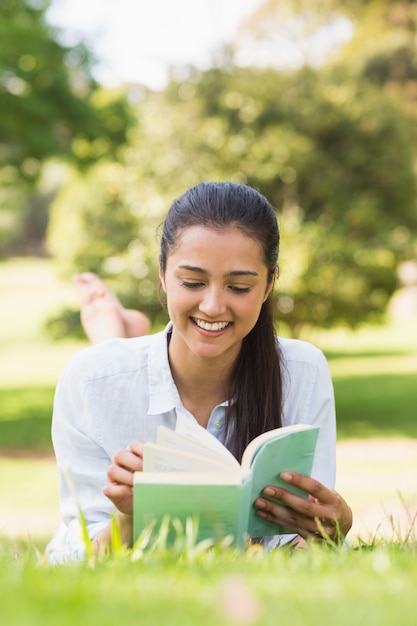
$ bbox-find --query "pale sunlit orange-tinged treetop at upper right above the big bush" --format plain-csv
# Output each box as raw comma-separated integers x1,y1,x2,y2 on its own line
235,0,417,133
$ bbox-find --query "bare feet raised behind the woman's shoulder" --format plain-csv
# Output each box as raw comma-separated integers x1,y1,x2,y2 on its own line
73,272,150,343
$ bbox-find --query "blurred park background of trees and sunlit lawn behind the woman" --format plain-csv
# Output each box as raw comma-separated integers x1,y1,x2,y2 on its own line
0,0,417,544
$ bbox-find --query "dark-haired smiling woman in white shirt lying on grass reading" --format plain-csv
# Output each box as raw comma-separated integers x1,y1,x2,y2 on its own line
46,182,352,560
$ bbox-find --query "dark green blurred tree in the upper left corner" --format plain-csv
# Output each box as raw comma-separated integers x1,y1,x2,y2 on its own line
0,0,132,254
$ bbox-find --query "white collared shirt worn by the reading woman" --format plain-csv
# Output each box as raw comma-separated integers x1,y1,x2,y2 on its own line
47,325,336,562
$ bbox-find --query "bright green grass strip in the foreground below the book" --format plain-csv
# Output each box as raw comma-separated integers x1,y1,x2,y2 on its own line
0,532,417,626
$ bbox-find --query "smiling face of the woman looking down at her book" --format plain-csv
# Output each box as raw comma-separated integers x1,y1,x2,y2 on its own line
160,226,272,365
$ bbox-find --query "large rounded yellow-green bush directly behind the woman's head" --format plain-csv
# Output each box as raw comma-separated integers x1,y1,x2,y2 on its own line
50,61,417,335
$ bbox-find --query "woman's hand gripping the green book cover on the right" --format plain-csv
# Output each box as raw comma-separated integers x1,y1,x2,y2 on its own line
254,472,352,543
